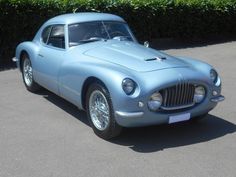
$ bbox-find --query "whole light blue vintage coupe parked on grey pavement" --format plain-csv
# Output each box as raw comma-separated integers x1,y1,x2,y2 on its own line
13,13,224,139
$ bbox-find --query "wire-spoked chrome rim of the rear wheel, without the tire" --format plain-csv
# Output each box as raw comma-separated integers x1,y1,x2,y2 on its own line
23,58,33,86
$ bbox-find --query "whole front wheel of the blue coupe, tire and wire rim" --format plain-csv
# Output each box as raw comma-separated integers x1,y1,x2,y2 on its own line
86,83,122,139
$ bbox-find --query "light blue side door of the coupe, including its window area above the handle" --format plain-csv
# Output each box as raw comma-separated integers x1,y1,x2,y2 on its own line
37,24,66,94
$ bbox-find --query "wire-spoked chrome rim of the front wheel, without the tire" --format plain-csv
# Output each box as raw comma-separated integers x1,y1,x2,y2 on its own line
89,90,110,131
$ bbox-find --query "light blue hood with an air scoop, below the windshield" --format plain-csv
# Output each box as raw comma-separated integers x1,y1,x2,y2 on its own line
84,41,189,72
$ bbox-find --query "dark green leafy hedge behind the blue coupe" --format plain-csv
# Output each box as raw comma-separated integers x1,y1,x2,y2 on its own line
0,0,236,64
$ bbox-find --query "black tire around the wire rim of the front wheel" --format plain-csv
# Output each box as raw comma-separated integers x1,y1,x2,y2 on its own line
86,82,122,140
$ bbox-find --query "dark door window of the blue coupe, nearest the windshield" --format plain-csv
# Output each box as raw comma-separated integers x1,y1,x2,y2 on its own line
47,25,65,49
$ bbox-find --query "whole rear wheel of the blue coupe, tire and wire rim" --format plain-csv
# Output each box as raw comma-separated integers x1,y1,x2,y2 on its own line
22,54,40,92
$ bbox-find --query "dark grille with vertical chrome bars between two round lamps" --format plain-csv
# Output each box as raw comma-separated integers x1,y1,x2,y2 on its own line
160,83,195,110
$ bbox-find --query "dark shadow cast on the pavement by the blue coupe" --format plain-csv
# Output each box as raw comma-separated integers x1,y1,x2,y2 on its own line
38,89,236,153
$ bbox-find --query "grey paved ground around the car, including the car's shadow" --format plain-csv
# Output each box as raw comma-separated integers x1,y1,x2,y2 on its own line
0,42,236,177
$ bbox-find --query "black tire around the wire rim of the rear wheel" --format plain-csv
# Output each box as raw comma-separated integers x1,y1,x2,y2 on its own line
21,53,41,92
